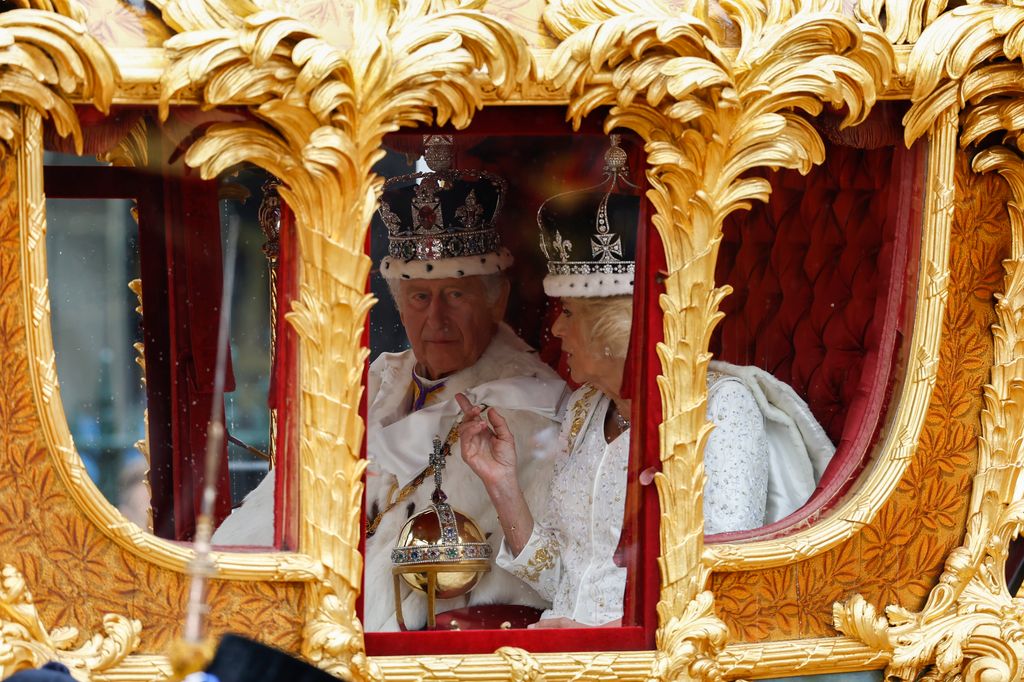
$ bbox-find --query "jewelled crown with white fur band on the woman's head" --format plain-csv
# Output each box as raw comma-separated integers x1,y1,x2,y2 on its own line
537,135,640,297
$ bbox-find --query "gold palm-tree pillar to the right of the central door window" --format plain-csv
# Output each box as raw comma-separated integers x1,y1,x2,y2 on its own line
545,0,895,679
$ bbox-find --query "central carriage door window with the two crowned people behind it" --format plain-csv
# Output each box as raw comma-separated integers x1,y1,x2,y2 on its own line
364,136,640,631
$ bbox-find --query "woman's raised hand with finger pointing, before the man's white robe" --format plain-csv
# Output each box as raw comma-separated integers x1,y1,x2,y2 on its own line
455,393,517,488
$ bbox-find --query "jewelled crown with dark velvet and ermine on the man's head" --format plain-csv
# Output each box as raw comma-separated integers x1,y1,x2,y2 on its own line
379,135,512,280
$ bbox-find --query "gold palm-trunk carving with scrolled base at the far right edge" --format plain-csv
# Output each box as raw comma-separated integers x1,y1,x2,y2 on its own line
835,147,1024,680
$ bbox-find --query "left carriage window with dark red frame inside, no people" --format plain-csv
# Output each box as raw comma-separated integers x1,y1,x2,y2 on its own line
45,111,284,546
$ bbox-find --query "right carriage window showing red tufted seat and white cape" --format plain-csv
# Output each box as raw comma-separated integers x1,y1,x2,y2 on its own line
705,131,924,542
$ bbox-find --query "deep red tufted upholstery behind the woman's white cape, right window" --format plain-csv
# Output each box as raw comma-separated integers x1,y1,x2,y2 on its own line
711,140,923,541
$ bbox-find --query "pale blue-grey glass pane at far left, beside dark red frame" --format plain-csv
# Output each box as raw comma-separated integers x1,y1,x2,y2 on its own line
46,199,150,527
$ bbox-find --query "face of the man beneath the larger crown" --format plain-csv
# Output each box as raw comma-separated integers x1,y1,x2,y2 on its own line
397,276,506,379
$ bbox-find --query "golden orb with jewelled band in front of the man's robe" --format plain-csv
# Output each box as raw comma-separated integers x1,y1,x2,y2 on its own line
391,503,490,599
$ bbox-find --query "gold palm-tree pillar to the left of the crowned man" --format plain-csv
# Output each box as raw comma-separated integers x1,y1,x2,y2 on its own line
154,2,530,677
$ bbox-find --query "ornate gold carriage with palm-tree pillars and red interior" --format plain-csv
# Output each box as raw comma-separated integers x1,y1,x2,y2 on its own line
0,0,1024,681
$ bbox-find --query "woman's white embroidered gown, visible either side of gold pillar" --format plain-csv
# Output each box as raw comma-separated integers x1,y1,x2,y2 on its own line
497,372,768,626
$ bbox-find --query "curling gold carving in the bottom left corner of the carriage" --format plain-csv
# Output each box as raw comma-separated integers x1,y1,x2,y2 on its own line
0,564,142,679
